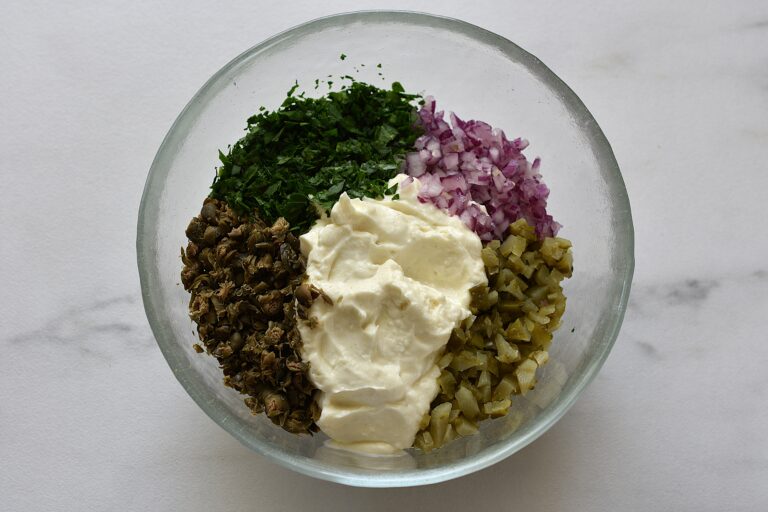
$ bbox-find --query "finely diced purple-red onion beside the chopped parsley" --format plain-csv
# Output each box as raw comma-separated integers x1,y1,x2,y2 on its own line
404,96,560,241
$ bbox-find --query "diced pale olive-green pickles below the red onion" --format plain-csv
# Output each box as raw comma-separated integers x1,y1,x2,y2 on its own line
414,219,573,452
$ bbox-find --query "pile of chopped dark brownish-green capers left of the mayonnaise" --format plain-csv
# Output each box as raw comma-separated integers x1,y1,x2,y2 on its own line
181,198,320,433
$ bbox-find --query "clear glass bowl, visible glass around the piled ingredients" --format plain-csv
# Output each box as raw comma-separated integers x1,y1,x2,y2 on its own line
137,12,634,487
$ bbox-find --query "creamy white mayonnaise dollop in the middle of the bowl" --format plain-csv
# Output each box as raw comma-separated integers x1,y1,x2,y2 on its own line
300,175,486,453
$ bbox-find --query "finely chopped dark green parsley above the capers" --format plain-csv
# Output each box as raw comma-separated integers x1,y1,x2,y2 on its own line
211,77,420,233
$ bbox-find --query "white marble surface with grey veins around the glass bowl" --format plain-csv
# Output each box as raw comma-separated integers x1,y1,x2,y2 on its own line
0,0,768,512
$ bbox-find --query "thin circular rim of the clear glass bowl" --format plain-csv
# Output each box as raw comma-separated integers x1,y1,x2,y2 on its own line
136,10,634,487
